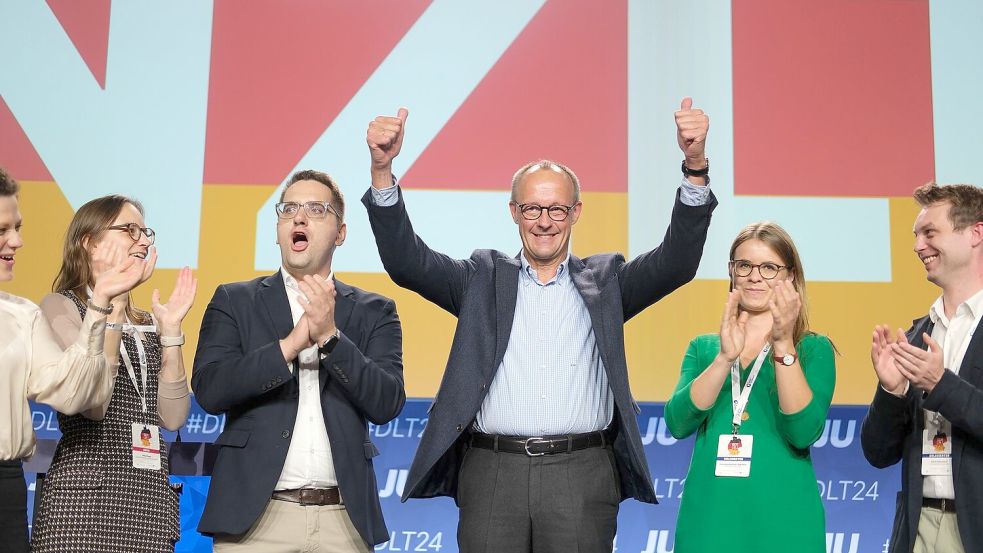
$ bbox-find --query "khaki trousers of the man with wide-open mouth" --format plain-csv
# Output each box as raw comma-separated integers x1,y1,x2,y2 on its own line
214,499,371,553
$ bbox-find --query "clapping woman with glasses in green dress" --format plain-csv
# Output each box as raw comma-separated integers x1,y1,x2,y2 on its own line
665,222,836,553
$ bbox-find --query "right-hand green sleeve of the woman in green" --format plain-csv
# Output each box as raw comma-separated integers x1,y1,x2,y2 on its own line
778,334,836,449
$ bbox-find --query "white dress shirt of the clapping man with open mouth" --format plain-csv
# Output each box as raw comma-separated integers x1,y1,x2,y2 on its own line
276,267,338,490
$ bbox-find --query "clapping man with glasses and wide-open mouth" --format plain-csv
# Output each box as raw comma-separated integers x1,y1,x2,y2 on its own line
191,171,406,553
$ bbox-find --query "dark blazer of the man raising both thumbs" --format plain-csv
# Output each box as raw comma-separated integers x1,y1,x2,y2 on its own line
362,190,717,503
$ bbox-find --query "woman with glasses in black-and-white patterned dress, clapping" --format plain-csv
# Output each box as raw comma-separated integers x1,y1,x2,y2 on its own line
31,195,197,553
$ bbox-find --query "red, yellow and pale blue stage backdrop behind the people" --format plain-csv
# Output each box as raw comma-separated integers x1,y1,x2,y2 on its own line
0,0,983,551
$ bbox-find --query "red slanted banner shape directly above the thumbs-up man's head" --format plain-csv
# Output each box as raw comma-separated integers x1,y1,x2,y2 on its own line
401,0,628,192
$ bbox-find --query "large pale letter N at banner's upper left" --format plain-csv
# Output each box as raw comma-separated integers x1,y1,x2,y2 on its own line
0,0,212,268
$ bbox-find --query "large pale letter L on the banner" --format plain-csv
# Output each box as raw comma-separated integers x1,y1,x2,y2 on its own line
628,0,891,282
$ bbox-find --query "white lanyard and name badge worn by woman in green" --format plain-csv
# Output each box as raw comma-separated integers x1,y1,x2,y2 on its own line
713,344,771,478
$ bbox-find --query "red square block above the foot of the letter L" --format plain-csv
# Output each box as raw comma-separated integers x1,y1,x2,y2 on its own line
736,0,935,196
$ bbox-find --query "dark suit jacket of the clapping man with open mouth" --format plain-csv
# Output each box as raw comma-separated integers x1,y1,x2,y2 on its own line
191,273,406,545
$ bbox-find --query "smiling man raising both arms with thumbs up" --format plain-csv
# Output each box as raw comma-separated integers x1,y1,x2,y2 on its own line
362,98,716,553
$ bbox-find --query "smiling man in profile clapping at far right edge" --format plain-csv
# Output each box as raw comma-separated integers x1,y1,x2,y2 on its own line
860,183,983,553
